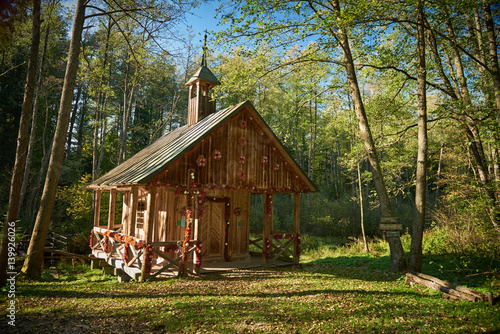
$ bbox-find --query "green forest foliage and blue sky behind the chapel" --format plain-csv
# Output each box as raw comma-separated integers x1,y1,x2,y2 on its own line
0,0,500,276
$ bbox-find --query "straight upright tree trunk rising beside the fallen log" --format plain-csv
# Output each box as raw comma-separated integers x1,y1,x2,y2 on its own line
408,0,427,272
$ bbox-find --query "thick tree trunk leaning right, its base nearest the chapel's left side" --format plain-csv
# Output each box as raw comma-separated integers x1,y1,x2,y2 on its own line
21,0,86,279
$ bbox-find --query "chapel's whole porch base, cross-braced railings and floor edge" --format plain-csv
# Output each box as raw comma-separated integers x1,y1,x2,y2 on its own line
90,227,300,281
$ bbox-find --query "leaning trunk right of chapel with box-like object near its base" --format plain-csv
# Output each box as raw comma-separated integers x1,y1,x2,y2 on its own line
332,0,406,271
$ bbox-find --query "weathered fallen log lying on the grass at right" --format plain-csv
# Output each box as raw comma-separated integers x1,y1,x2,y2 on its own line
406,272,488,302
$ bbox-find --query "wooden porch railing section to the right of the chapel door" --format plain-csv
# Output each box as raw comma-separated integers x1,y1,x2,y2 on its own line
250,230,300,265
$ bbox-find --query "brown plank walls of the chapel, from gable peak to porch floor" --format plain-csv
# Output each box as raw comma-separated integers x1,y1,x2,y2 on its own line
108,109,310,262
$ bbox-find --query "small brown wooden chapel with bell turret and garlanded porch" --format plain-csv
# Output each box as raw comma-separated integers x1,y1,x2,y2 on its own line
88,50,317,280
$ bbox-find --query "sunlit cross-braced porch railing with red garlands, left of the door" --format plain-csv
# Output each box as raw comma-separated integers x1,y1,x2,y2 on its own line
91,227,202,277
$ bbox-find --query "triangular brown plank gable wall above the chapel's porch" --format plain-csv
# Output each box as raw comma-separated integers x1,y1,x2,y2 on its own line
150,111,309,192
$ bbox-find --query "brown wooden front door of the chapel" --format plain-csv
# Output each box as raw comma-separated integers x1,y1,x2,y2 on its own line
200,202,225,262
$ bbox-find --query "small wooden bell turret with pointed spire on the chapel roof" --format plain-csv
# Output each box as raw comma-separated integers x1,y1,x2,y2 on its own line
186,35,220,125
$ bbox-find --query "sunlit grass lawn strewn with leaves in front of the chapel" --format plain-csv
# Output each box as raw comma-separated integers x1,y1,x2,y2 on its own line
0,236,500,333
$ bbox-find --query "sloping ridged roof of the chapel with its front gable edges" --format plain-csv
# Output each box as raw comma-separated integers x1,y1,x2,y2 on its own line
88,101,318,192
